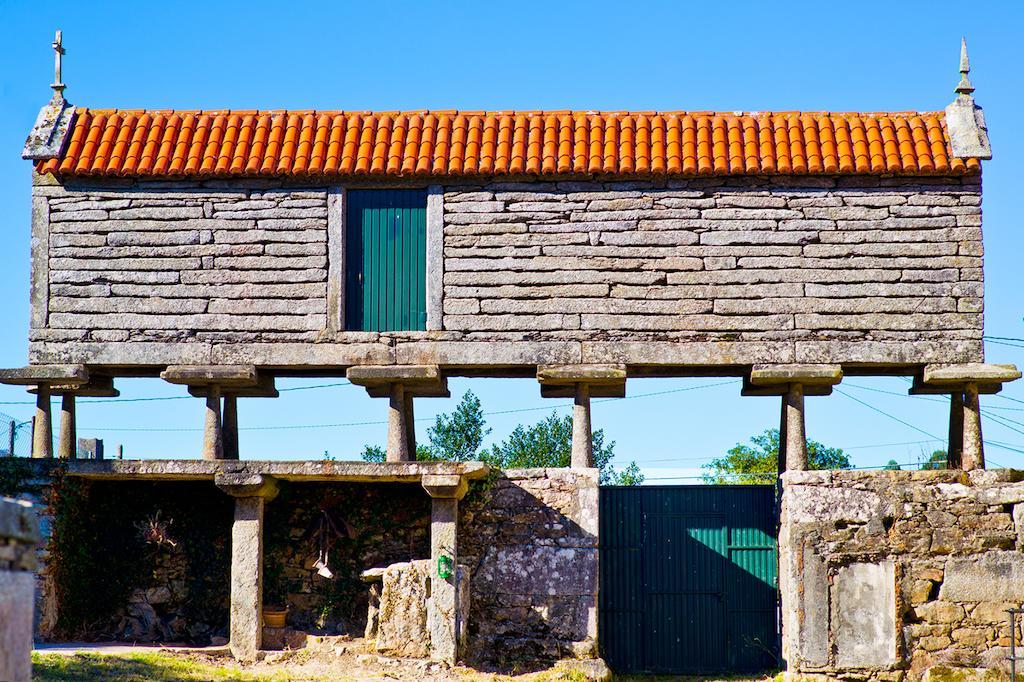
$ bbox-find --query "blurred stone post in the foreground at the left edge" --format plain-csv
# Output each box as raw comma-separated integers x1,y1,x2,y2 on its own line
0,498,40,682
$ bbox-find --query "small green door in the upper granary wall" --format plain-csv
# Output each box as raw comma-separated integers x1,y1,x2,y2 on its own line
345,189,427,332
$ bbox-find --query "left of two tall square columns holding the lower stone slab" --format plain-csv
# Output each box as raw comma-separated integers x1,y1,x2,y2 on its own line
215,474,278,663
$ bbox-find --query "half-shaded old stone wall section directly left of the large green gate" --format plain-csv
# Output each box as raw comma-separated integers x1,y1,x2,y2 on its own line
459,469,598,667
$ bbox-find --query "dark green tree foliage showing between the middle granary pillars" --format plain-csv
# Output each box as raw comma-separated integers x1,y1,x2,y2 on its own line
362,391,643,485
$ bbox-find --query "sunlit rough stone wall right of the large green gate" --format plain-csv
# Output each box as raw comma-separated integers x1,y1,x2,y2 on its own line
779,470,1024,680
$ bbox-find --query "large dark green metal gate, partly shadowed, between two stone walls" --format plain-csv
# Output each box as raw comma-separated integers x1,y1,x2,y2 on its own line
598,485,779,675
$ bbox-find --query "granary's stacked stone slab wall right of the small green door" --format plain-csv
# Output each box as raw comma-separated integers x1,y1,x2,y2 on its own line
444,177,983,363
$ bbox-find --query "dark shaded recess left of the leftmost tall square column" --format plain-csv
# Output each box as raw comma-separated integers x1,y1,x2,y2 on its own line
47,477,233,644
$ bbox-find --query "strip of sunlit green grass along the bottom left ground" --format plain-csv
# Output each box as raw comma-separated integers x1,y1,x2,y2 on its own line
32,653,289,682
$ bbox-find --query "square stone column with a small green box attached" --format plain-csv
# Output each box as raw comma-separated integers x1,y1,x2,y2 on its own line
423,474,468,666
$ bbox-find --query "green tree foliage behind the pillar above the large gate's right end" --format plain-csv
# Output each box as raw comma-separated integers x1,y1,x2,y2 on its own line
703,429,851,484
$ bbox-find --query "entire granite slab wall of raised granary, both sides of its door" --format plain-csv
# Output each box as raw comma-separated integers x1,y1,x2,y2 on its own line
30,176,983,367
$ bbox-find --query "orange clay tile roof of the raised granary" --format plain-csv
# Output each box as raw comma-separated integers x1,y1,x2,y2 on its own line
37,109,979,177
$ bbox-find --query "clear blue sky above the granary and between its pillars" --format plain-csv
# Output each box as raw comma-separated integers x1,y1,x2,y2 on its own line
0,0,1024,482
